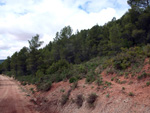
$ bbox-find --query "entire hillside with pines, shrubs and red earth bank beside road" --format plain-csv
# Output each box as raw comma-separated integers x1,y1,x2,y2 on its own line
0,0,150,113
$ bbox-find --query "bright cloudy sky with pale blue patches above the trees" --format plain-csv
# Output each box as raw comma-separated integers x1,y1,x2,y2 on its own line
0,0,129,59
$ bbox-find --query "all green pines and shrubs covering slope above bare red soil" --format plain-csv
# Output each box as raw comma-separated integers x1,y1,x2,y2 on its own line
0,0,150,92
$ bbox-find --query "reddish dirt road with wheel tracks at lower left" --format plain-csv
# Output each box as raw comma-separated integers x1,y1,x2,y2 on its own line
0,75,37,113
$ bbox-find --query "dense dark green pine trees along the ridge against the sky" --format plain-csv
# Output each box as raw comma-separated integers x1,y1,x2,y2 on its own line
0,0,150,87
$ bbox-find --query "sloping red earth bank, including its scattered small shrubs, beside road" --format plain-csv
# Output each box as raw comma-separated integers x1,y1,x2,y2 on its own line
31,58,150,113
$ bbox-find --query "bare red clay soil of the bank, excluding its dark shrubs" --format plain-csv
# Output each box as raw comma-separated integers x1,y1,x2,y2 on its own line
34,58,150,113
